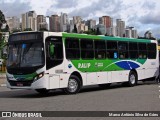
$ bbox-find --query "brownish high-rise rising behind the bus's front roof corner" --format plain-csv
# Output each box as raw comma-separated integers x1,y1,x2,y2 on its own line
49,15,60,32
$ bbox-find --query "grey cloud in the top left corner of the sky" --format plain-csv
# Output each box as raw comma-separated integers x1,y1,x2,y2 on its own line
0,0,31,17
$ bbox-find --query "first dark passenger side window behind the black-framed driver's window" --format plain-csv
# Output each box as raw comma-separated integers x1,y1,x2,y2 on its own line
65,38,80,59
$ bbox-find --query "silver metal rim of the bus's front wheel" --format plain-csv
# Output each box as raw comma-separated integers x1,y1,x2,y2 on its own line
68,79,78,93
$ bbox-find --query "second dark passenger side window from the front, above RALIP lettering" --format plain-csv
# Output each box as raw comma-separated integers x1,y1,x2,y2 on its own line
80,39,94,59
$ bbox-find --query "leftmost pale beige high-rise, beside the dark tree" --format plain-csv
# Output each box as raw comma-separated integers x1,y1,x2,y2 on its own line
6,16,20,32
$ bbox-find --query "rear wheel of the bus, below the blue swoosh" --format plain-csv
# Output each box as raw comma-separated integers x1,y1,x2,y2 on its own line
128,71,137,87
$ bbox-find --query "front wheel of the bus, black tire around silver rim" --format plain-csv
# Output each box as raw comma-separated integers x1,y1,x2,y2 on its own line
64,75,82,94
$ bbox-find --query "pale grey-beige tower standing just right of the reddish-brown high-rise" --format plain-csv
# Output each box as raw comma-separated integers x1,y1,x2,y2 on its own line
116,19,125,37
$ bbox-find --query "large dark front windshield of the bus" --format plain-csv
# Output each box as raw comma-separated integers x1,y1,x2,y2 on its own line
7,43,44,68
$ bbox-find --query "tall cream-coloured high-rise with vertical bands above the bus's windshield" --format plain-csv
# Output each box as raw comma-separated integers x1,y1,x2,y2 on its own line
22,11,37,31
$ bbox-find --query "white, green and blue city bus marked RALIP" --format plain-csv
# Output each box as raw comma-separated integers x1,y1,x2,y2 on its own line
6,32,159,94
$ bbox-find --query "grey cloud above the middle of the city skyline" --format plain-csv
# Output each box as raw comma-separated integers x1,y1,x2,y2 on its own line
69,0,123,19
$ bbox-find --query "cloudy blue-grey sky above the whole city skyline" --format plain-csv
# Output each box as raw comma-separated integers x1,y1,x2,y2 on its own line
0,0,160,38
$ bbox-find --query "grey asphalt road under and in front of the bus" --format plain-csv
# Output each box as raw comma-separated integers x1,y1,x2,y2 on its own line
0,82,160,120
